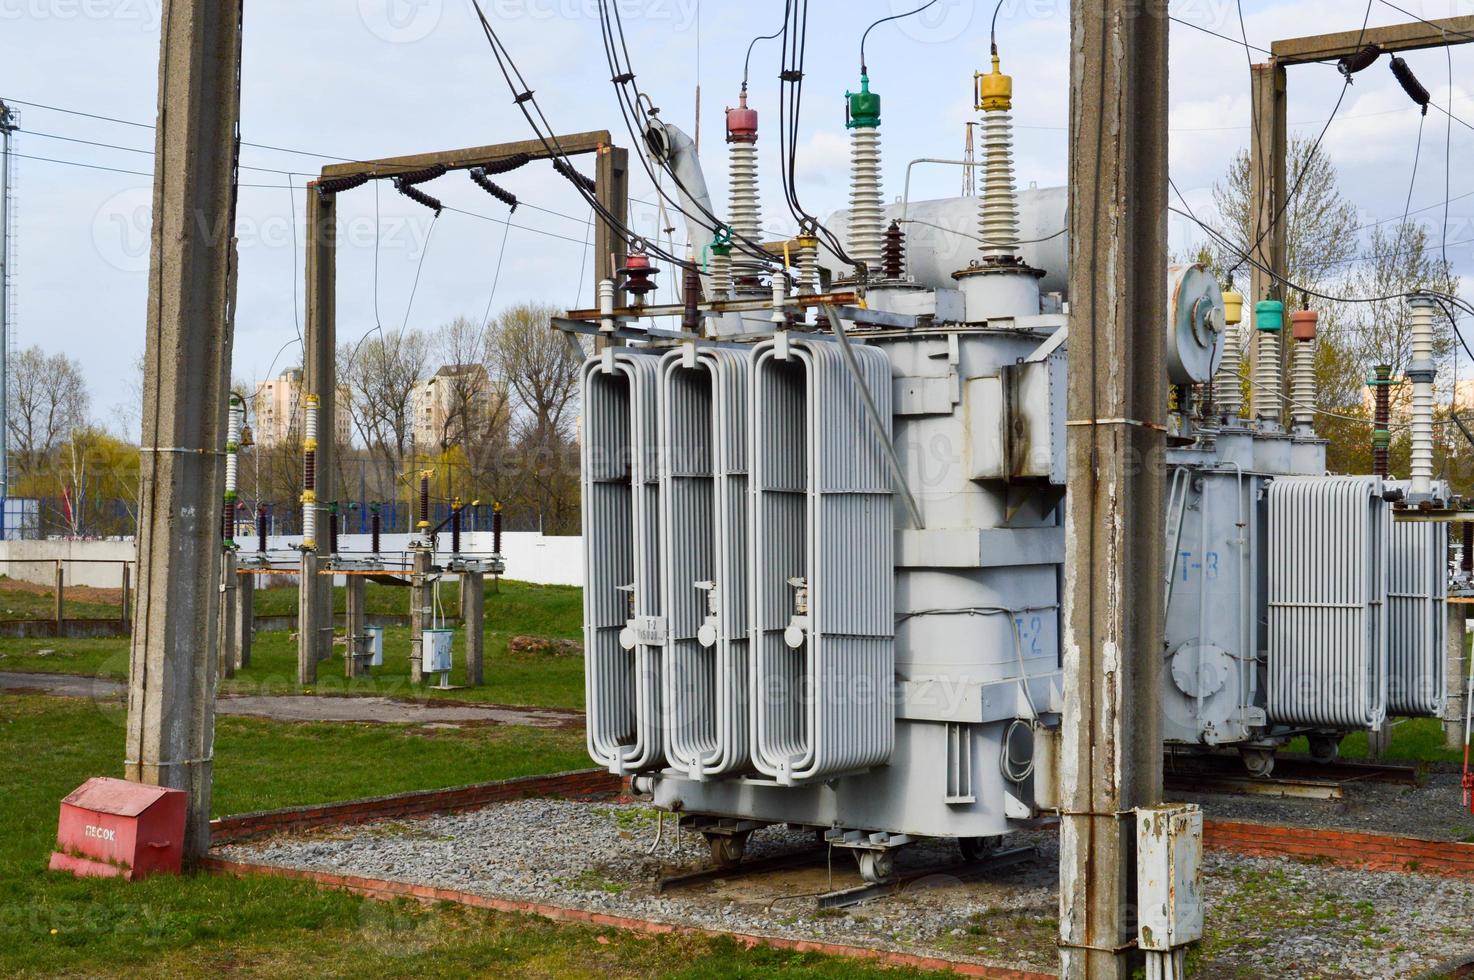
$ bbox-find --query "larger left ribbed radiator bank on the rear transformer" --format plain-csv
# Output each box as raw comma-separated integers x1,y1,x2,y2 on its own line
1266,476,1391,728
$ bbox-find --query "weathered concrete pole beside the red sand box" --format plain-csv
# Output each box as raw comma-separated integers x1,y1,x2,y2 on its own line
124,0,240,858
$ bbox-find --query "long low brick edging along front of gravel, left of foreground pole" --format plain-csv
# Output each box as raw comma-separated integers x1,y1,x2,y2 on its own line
196,854,1054,980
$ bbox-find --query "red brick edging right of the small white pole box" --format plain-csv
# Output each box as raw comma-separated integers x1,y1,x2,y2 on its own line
1203,819,1474,877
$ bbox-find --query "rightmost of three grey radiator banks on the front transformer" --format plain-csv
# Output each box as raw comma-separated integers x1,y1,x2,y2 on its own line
752,336,895,785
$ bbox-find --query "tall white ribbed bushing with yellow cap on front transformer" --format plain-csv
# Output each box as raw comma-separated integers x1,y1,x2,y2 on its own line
952,55,1044,323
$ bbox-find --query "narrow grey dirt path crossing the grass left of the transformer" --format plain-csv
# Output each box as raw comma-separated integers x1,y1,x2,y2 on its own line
0,671,584,728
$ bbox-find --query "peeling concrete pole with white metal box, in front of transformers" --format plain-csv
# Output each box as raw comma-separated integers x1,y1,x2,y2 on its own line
1060,0,1167,980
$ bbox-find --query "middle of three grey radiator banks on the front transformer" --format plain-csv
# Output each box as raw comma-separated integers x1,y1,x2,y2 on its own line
659,346,750,780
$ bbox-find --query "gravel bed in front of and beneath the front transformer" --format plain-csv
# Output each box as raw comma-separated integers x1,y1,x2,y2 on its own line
220,800,1474,979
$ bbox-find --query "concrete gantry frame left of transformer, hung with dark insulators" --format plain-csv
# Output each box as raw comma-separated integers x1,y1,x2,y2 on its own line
298,130,629,672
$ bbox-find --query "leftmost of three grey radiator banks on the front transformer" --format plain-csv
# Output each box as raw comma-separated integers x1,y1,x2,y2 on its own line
581,348,665,774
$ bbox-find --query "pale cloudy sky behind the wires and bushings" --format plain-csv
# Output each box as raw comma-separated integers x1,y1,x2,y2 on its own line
0,0,1474,423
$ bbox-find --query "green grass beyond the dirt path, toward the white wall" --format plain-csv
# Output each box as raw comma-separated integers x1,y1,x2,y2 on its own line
0,582,584,707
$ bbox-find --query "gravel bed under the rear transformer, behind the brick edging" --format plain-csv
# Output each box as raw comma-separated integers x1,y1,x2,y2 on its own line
1167,772,1474,841
